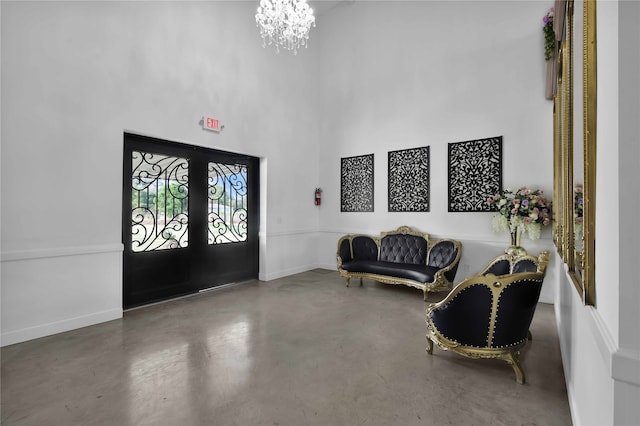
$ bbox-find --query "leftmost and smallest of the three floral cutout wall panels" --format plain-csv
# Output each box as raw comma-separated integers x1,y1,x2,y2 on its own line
340,154,373,212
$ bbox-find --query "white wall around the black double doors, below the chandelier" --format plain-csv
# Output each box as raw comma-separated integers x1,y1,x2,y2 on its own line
0,1,320,344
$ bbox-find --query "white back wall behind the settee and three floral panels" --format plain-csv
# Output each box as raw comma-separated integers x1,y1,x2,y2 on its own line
318,1,554,302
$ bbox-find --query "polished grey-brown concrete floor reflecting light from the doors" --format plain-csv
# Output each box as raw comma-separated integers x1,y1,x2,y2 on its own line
1,270,571,426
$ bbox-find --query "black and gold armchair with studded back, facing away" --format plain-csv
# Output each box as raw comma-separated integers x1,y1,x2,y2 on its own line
426,252,549,384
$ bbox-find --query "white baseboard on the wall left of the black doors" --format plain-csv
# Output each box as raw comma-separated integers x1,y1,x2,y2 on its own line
0,309,122,346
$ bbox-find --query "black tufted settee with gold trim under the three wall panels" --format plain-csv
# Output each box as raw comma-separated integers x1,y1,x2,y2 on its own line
337,226,462,300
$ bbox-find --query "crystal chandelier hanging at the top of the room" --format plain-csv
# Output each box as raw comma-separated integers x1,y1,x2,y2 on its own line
256,0,316,55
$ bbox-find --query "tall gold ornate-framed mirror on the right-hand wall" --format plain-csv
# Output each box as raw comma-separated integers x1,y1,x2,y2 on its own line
553,0,597,305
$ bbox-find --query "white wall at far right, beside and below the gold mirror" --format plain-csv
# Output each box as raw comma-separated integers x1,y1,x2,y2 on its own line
555,1,640,425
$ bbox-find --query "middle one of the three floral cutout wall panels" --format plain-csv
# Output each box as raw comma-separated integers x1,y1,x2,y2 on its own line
389,146,429,212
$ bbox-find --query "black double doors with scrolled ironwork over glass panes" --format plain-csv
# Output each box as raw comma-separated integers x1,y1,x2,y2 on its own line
122,133,259,309
